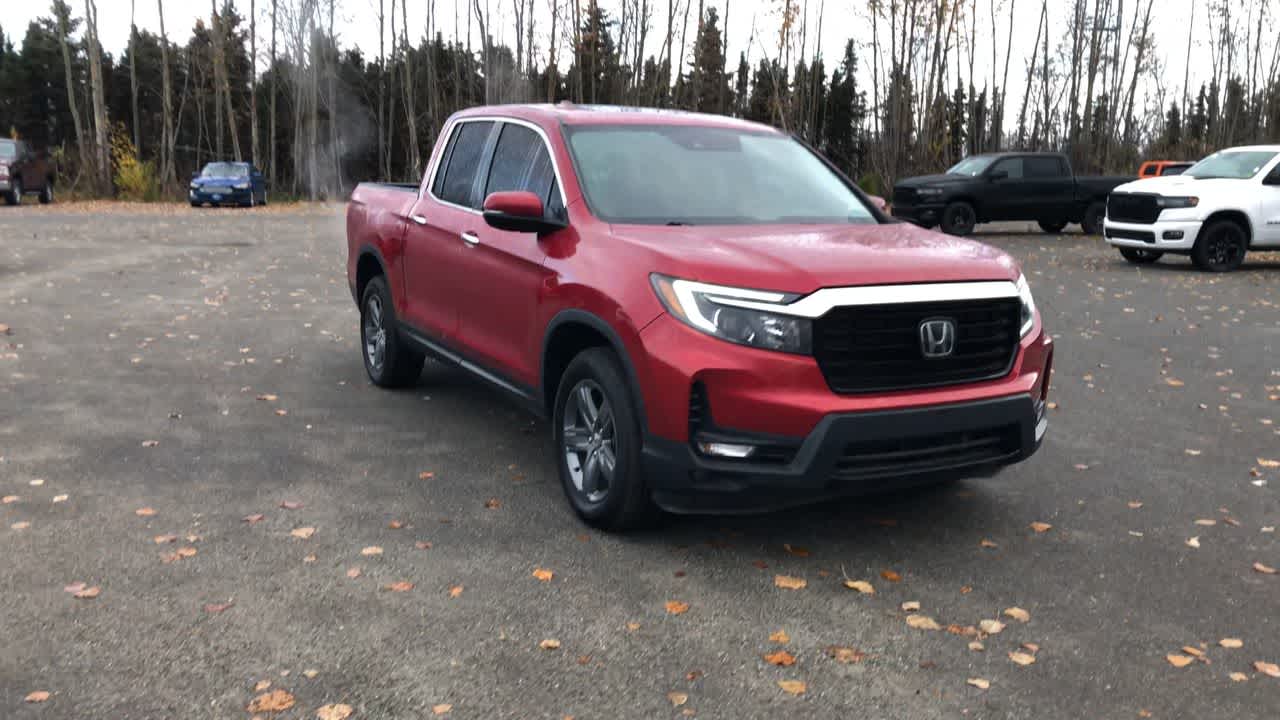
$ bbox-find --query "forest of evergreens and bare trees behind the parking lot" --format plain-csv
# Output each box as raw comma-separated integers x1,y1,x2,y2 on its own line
0,0,1280,197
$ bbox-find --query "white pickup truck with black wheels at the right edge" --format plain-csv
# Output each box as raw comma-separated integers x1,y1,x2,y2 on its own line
1103,145,1280,273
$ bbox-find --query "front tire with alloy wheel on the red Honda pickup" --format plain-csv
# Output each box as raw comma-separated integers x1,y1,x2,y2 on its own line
552,347,654,530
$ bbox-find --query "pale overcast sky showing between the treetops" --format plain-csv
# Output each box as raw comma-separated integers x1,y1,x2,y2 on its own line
0,0,1259,115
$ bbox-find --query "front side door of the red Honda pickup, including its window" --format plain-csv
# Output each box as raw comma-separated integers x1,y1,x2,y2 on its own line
458,120,563,391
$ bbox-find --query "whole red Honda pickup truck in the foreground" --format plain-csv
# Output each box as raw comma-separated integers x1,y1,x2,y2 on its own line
347,104,1053,529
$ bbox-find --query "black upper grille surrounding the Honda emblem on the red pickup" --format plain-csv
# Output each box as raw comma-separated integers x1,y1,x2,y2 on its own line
813,297,1021,393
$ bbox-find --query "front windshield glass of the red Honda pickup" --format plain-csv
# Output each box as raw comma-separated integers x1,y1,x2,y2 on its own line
566,126,876,225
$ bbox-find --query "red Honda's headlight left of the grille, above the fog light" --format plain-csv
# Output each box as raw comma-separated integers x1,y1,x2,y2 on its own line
650,274,813,355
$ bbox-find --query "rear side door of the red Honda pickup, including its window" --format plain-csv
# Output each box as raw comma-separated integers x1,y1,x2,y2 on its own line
397,119,494,342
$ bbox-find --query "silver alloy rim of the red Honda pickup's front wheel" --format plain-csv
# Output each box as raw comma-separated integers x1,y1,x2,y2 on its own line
562,379,618,503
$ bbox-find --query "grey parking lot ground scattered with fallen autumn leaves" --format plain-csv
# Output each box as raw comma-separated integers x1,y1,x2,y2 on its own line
0,204,1280,720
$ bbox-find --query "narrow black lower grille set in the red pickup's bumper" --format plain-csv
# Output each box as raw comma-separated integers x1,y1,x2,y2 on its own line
832,425,1020,482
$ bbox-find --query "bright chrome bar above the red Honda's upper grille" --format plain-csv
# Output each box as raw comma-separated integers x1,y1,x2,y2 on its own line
711,281,1019,319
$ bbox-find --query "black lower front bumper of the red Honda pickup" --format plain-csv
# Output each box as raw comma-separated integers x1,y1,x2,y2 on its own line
643,395,1048,512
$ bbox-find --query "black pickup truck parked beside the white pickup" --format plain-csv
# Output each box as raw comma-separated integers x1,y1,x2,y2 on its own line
892,152,1137,236
